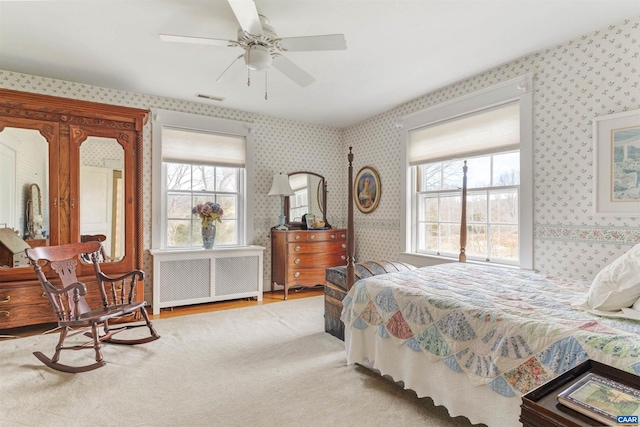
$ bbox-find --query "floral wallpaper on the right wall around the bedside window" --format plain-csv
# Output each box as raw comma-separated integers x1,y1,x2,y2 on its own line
342,17,640,280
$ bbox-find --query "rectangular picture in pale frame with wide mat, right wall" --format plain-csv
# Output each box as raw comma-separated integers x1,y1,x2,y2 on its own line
593,110,640,216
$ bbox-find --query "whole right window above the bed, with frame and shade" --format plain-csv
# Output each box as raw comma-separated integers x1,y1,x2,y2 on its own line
401,75,533,269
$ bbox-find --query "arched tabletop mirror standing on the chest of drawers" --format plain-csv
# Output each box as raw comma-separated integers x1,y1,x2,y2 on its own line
284,171,330,229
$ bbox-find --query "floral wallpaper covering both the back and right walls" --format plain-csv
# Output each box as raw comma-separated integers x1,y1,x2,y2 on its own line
0,17,640,298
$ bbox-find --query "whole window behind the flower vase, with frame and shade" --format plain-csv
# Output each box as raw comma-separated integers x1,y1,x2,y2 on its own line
152,110,252,249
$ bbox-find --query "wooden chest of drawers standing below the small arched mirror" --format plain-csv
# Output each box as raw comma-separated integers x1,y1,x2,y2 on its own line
271,229,347,299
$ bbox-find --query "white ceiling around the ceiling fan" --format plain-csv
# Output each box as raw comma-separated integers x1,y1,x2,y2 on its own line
0,0,640,127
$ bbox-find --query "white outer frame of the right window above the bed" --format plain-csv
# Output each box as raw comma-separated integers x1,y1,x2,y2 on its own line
397,73,533,270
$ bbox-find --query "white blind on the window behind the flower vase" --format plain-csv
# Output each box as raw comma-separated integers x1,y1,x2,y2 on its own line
162,126,246,168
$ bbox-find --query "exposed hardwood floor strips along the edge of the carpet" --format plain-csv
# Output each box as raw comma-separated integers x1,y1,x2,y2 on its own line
0,286,324,339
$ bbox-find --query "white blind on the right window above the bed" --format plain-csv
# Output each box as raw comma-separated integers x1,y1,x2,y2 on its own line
409,102,520,166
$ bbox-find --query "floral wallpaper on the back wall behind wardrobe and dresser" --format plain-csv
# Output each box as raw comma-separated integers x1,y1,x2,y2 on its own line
0,70,346,301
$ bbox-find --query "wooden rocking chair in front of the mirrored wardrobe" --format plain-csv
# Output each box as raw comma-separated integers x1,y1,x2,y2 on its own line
25,241,160,373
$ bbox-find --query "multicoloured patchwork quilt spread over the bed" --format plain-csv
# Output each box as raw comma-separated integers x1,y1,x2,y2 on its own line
341,263,640,397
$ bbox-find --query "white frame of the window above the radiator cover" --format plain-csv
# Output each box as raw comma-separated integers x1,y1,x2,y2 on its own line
151,109,255,250
